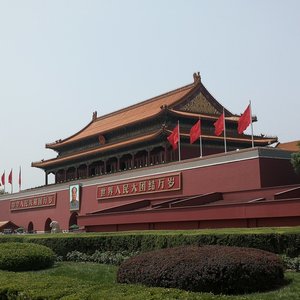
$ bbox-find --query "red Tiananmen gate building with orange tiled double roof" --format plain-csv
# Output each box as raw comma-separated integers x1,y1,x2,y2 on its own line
0,73,300,232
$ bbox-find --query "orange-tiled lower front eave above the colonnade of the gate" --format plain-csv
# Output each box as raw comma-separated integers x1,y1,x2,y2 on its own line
31,129,162,169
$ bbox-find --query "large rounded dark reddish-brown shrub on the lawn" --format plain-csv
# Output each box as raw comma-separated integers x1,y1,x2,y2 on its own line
117,246,284,294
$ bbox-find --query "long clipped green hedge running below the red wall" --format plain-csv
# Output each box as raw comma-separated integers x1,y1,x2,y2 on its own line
0,229,300,257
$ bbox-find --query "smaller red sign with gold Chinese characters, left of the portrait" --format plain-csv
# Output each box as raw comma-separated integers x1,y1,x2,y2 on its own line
10,193,56,211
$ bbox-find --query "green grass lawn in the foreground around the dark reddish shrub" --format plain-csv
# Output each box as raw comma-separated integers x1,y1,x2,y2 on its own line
0,262,300,300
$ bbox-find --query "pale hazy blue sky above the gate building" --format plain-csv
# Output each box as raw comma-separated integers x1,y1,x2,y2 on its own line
0,0,300,191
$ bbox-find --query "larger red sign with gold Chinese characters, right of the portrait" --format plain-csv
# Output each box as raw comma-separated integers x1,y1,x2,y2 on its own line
97,173,181,200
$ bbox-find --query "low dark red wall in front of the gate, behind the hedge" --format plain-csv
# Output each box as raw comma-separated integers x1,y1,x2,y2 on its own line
79,198,300,231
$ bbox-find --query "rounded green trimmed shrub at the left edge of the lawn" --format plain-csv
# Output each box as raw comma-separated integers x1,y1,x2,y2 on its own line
0,243,55,271
